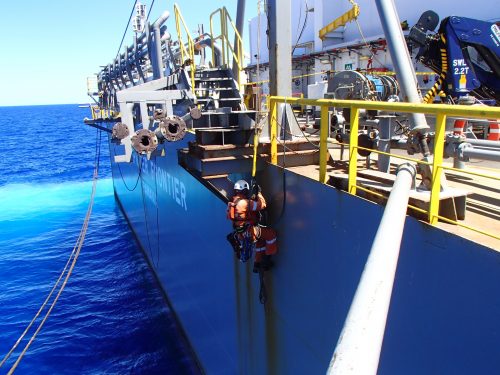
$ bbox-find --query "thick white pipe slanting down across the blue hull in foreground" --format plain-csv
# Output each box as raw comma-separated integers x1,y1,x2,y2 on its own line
327,163,416,375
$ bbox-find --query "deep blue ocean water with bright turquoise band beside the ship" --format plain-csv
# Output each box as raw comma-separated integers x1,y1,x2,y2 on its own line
0,105,198,374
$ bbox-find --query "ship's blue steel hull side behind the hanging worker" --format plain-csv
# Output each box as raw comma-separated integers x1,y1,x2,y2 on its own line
110,134,500,374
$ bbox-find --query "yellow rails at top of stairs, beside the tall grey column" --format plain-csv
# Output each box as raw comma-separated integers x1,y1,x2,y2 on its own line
210,7,244,84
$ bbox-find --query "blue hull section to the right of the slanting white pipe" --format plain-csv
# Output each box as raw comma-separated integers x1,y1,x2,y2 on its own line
379,219,500,374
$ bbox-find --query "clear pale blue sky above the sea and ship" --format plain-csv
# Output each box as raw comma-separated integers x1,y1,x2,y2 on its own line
0,0,257,106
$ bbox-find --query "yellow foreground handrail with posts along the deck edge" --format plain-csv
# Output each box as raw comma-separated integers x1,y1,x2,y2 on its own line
268,96,500,239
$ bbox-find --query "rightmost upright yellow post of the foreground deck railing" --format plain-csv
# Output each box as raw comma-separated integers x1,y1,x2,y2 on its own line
429,113,446,225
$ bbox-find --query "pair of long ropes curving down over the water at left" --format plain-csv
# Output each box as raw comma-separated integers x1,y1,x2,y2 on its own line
0,130,101,375
